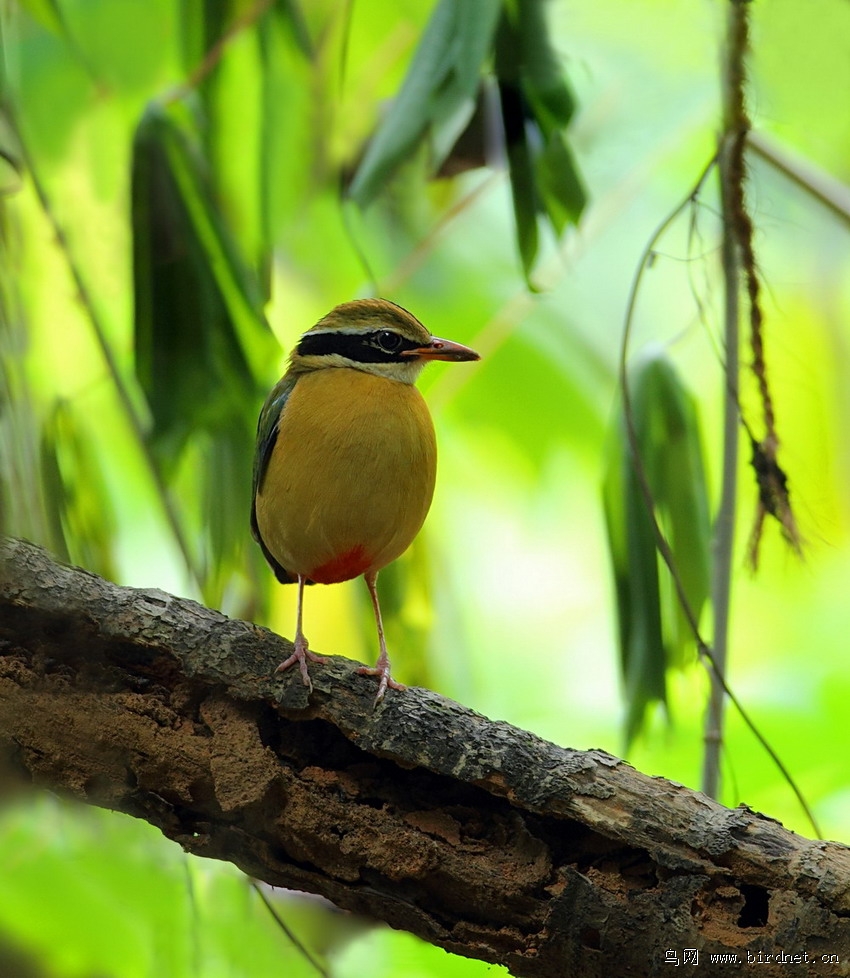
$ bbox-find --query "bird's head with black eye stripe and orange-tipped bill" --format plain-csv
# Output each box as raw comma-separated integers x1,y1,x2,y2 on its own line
290,299,479,384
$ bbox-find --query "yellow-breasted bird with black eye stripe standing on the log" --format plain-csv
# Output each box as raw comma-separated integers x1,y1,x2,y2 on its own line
251,299,480,704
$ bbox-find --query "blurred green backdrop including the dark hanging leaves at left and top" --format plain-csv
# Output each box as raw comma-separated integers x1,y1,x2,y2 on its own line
0,0,850,978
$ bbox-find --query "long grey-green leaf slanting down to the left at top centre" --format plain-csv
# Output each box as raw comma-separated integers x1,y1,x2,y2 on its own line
349,0,500,207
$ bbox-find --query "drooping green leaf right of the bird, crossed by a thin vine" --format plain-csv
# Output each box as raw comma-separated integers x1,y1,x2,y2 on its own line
603,351,710,740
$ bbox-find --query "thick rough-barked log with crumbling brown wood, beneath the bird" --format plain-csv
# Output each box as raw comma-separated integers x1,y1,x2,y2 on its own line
0,541,850,978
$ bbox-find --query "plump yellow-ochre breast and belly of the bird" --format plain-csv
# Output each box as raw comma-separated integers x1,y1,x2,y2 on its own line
252,367,437,584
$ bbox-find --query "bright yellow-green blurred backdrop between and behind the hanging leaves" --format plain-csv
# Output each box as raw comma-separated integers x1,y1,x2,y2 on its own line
0,0,850,978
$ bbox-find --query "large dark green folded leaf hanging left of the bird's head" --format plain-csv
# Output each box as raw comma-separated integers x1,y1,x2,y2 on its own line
132,106,276,465
